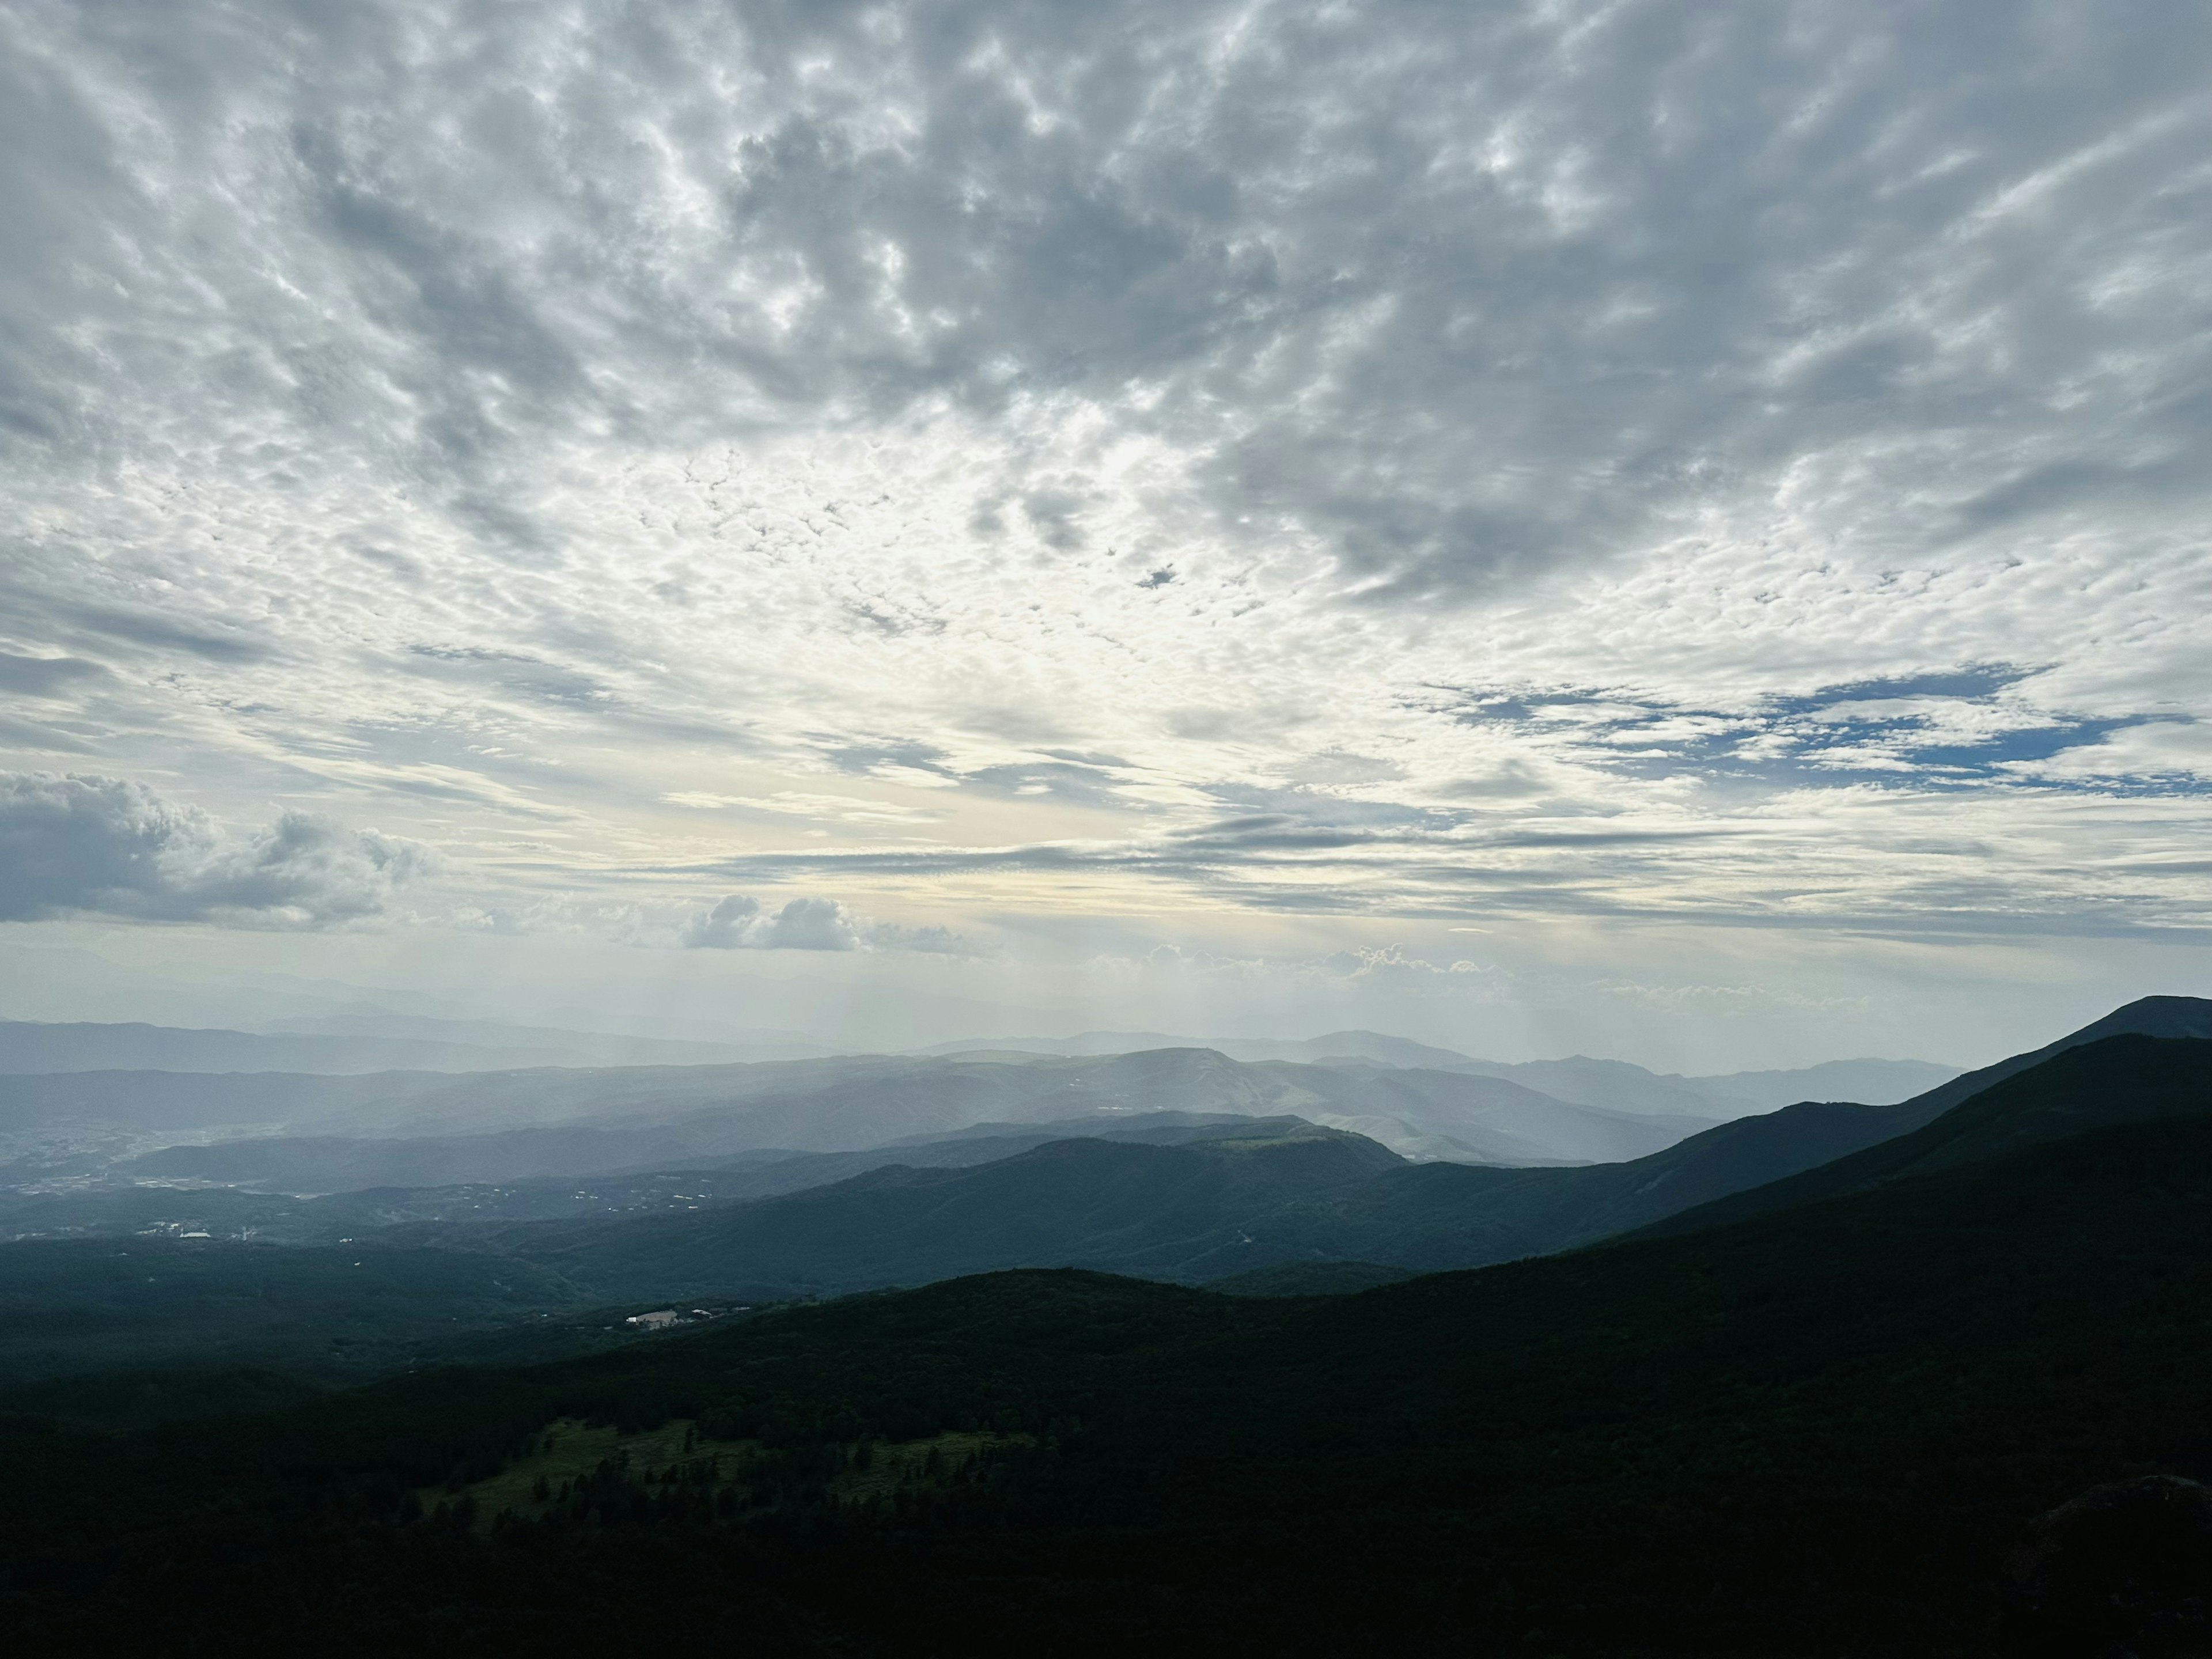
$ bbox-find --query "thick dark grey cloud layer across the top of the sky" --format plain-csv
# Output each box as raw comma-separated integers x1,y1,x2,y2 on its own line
0,0,2212,597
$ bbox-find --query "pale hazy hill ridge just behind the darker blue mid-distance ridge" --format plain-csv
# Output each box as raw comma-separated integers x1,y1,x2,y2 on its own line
0,1048,1714,1192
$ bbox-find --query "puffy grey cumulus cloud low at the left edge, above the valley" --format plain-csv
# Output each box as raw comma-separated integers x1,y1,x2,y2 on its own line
0,772,429,927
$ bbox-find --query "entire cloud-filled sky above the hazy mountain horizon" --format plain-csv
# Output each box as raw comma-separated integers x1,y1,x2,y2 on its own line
0,0,2212,1069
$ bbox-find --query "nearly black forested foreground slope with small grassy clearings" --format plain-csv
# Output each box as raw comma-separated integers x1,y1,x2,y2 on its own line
0,1044,2212,1654
